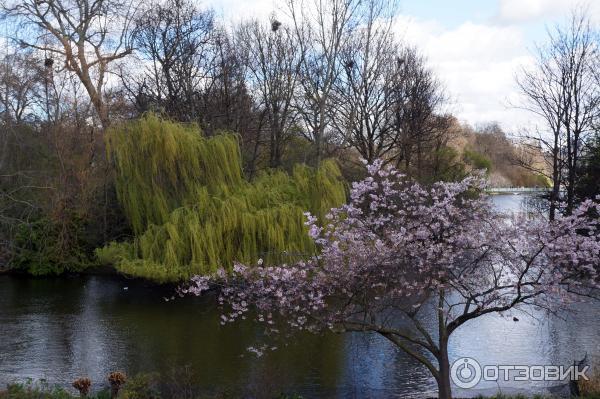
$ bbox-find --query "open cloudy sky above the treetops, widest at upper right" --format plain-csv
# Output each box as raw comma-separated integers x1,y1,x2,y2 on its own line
203,0,600,135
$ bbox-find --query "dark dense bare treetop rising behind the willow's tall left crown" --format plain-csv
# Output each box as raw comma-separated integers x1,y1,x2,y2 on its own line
127,0,215,122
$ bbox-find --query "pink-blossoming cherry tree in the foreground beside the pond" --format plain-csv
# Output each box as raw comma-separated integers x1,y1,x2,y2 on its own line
181,161,600,398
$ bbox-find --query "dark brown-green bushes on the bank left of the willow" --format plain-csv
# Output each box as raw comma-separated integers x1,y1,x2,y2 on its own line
0,120,129,276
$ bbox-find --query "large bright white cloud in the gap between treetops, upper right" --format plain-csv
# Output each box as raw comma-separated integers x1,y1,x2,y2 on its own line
396,16,531,130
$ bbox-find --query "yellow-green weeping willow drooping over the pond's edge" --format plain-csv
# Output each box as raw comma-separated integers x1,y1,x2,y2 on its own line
97,115,346,282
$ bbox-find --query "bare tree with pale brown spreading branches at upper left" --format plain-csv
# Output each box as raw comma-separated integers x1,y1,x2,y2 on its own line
3,0,137,128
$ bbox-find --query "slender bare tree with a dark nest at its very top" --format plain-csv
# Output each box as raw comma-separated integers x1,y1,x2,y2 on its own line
238,18,302,168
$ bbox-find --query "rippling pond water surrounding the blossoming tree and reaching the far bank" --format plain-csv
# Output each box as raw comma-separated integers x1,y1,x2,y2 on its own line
0,196,600,398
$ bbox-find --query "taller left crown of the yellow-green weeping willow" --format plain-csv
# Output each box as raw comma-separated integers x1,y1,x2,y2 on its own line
106,114,243,233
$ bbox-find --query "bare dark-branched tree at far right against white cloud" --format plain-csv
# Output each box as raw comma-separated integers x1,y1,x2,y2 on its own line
517,11,600,219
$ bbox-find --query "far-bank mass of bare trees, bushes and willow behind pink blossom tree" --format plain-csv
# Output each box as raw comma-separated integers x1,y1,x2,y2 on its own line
0,0,548,281
